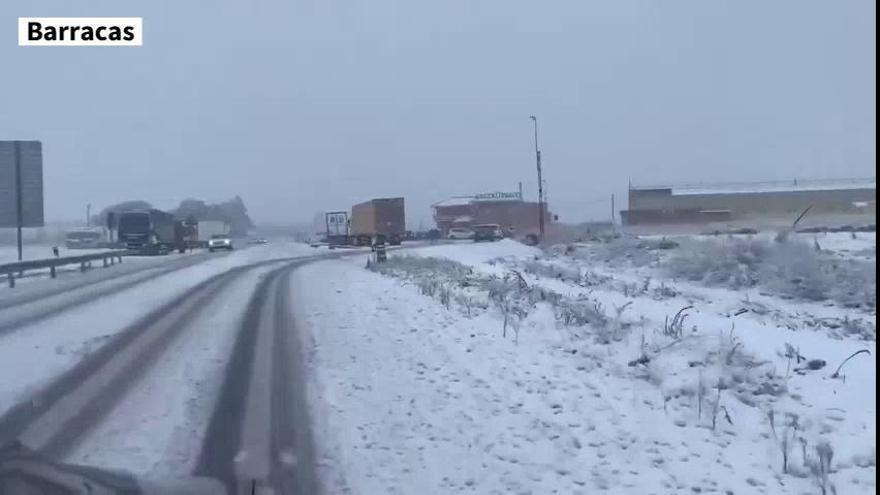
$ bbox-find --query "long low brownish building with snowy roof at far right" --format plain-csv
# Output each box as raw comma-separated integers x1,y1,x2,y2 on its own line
620,179,877,225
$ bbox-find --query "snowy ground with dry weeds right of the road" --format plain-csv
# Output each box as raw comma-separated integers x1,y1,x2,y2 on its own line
293,234,876,494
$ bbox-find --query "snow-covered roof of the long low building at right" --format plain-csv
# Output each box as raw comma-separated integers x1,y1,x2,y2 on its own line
630,178,877,196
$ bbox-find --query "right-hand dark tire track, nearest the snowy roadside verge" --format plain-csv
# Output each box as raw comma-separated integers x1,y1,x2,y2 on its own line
194,262,318,494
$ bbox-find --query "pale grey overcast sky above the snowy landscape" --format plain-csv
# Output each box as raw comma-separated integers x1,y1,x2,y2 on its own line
0,0,876,227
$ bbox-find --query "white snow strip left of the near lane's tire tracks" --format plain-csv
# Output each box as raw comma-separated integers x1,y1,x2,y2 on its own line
0,243,315,414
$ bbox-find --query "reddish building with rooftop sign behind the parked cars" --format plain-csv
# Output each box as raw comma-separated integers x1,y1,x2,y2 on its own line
431,191,552,235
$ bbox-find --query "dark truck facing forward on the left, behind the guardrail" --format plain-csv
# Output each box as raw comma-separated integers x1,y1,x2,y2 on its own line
117,209,179,254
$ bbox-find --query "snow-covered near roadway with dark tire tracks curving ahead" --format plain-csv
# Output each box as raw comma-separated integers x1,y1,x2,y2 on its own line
0,243,356,493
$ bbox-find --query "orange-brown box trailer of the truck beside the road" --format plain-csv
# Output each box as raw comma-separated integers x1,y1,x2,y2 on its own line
351,198,406,246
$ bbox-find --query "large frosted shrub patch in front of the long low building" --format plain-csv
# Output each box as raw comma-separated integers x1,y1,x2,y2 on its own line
663,234,877,308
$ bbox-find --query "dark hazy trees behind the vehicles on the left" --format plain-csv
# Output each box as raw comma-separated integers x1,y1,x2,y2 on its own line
92,196,254,236
